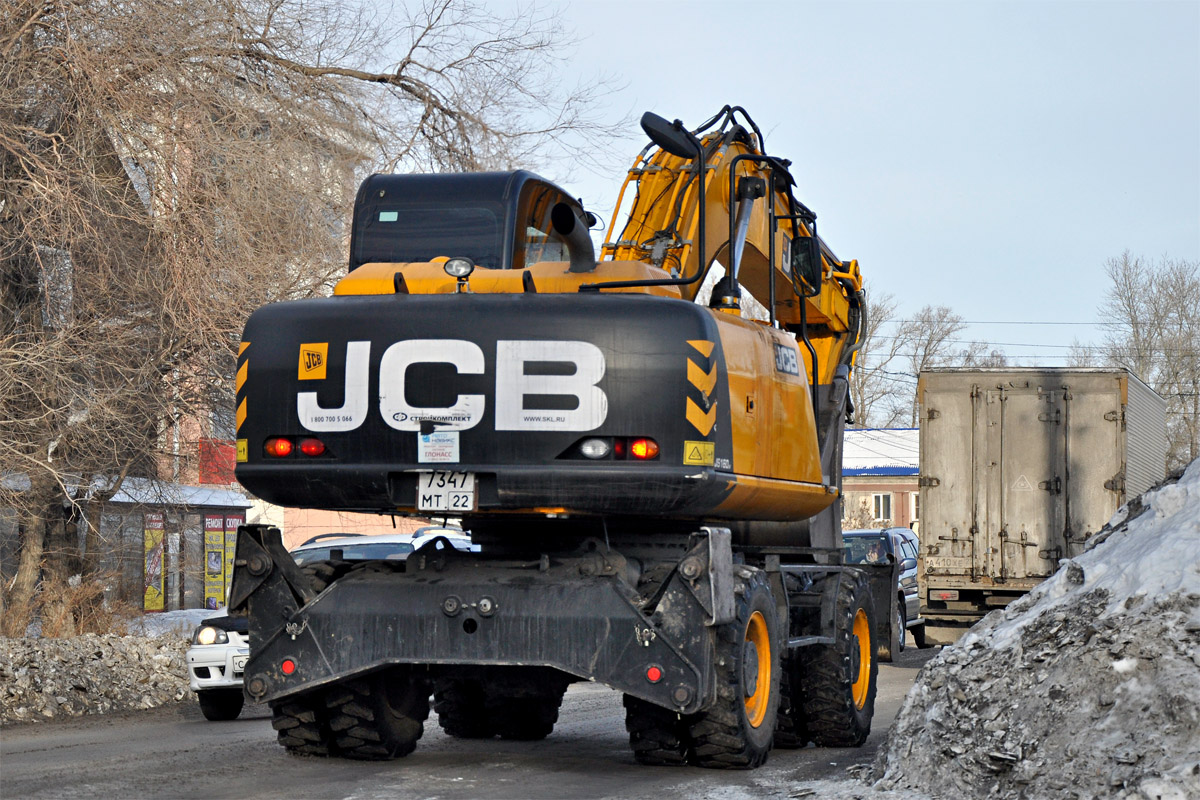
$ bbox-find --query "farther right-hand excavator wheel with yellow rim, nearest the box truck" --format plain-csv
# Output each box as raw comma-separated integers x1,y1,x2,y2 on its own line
797,571,878,747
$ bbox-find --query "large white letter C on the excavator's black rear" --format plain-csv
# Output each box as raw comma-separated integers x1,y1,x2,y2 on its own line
379,339,485,431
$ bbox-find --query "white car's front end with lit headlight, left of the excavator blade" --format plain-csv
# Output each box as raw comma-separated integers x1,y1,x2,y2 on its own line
187,616,250,722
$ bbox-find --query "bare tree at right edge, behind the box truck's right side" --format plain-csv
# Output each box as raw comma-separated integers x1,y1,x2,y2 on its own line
1100,251,1200,469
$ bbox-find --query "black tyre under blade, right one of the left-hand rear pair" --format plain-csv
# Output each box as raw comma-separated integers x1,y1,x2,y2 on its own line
325,668,430,762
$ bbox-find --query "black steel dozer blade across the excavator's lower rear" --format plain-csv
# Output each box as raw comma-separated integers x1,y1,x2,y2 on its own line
234,527,733,714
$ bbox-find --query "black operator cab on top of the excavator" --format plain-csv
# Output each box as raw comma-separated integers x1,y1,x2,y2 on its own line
350,169,586,271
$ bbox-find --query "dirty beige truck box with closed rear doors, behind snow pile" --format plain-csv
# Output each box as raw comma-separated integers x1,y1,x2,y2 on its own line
917,367,1166,644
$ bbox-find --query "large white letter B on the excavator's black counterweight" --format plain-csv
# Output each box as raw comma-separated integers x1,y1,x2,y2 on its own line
496,341,608,431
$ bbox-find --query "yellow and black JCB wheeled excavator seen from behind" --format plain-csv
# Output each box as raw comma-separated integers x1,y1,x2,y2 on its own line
230,107,890,768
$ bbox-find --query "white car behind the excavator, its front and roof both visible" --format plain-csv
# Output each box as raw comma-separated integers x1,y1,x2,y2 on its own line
187,525,479,722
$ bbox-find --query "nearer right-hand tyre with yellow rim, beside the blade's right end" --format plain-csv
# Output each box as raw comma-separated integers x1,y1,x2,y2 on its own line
688,567,782,769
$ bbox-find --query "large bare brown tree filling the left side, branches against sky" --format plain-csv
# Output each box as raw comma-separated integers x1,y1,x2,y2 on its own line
0,0,619,633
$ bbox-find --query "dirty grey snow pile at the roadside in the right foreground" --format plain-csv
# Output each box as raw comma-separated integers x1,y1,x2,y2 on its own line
875,461,1200,800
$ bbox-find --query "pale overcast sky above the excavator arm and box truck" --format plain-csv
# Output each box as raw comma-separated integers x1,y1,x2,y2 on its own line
528,0,1200,365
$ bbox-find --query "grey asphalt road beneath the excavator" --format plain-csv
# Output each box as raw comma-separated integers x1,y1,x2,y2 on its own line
0,639,936,800
